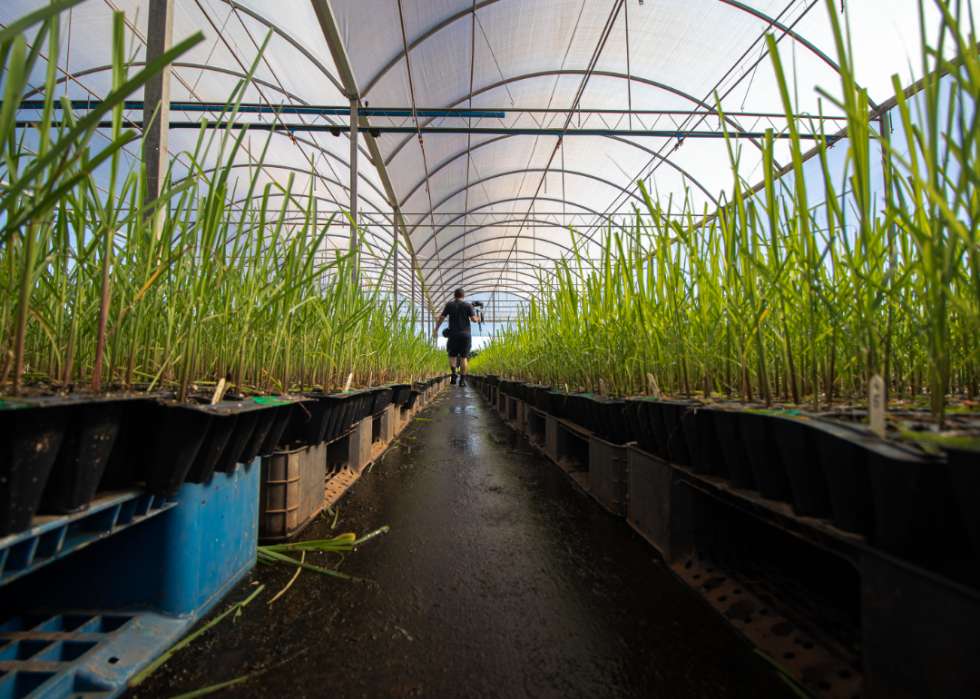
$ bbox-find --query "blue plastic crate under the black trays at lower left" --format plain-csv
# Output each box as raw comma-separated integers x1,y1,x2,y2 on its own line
0,460,260,699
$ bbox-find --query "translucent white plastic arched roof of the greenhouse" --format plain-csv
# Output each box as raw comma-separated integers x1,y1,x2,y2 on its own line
0,0,972,306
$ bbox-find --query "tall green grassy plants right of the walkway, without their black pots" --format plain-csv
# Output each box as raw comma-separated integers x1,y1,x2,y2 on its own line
473,1,980,423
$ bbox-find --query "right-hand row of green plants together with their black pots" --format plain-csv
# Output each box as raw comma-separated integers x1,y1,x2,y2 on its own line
471,1,980,587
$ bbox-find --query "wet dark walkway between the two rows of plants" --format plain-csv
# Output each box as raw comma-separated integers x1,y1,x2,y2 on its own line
126,387,794,699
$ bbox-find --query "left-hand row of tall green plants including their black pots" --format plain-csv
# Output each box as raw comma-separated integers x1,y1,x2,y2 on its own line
0,0,442,536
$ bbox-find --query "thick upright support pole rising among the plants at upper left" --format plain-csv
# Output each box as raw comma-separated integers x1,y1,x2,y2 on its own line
143,0,174,238
